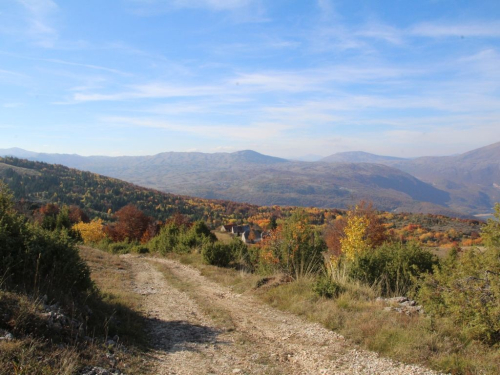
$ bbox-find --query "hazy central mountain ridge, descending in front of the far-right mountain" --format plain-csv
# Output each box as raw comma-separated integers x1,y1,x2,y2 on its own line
0,150,459,215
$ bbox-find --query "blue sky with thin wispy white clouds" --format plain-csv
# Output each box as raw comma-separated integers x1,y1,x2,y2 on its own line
0,0,500,158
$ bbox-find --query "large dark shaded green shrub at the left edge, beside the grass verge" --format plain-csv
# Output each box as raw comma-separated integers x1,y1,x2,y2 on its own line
0,184,93,295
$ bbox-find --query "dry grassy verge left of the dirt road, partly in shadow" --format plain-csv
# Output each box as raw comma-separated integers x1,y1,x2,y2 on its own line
0,248,149,375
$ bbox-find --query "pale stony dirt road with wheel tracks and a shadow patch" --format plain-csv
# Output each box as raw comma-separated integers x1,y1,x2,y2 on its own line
123,255,442,375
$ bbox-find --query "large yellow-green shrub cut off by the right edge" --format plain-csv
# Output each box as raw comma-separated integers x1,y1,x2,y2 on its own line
417,203,500,345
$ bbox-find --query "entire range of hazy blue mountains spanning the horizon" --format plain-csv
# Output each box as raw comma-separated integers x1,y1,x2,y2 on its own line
0,143,500,216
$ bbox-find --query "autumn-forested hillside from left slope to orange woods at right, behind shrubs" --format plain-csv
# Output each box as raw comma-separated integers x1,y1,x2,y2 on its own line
0,158,482,246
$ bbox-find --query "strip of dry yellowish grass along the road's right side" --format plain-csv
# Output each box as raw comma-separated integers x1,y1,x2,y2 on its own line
171,255,500,374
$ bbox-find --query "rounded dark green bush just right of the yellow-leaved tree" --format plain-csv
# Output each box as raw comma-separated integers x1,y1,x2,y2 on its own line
348,243,438,295
